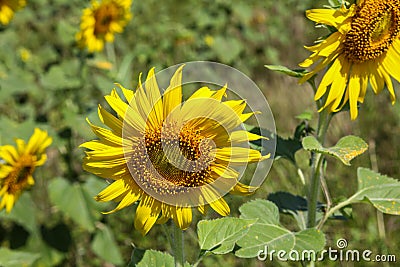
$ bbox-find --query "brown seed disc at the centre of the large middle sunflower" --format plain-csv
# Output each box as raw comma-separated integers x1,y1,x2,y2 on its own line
129,124,214,195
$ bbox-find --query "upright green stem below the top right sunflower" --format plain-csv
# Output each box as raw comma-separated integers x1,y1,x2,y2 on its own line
307,109,332,228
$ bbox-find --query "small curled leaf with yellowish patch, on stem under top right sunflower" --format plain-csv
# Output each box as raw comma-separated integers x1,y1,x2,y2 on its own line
303,135,368,165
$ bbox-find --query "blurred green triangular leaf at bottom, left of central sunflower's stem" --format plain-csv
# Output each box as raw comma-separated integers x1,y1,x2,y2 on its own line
92,225,123,265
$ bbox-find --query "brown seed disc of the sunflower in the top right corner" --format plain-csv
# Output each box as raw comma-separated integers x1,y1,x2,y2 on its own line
344,0,400,63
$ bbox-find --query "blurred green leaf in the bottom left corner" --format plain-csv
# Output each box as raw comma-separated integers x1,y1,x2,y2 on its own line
0,248,40,267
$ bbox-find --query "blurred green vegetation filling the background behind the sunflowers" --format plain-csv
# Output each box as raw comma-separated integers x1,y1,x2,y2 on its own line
0,0,400,266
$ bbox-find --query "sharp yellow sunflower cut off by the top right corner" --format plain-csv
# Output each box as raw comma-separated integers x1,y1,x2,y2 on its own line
300,0,400,120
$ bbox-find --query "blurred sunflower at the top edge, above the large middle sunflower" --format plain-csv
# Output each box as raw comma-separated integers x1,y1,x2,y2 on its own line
76,0,132,52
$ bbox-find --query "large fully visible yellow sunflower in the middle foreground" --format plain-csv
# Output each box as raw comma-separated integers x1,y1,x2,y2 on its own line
81,66,269,235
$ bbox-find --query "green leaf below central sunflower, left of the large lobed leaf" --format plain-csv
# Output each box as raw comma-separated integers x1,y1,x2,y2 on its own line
197,217,257,254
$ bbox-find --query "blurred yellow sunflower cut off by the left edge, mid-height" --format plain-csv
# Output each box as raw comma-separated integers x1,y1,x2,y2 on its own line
0,128,52,212
